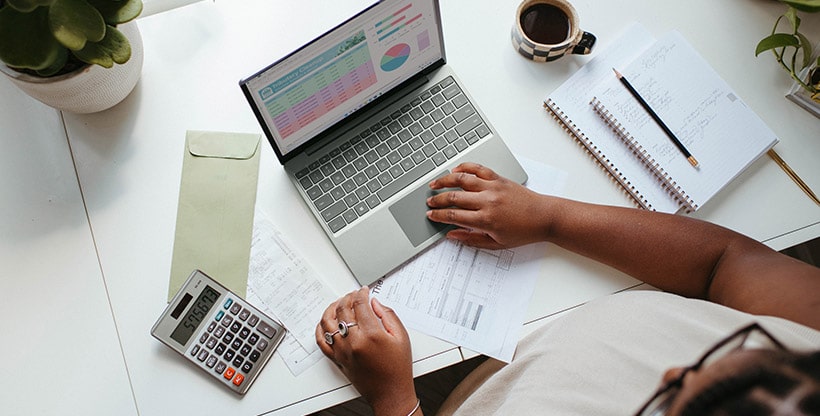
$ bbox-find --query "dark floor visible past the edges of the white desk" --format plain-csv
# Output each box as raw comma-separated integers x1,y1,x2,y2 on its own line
310,238,820,416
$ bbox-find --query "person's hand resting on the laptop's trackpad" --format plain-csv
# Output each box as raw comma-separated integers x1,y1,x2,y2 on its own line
427,163,548,249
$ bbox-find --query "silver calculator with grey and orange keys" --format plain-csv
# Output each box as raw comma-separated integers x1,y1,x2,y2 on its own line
151,270,285,395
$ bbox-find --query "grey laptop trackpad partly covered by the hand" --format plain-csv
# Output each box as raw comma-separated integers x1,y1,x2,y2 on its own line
390,171,455,247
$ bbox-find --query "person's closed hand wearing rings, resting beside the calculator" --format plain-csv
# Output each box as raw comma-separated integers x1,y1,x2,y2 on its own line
316,287,417,415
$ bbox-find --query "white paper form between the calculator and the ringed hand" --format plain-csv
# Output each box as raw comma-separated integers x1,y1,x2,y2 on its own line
247,211,336,375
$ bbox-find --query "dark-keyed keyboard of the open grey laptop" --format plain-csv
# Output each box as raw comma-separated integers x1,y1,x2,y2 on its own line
296,77,490,233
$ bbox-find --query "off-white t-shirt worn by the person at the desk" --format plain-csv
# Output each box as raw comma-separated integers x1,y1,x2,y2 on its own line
439,291,820,415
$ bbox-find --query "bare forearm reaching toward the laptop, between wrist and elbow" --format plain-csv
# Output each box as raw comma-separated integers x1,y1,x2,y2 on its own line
545,197,762,298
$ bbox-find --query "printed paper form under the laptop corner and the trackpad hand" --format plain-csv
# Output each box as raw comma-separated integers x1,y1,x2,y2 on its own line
371,157,567,362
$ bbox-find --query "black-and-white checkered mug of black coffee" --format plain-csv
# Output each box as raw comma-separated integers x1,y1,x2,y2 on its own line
512,0,595,62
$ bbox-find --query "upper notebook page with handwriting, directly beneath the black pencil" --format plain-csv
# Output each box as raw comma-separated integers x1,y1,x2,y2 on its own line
598,32,777,208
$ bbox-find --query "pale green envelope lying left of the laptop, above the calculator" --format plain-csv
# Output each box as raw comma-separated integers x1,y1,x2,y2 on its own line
168,131,261,301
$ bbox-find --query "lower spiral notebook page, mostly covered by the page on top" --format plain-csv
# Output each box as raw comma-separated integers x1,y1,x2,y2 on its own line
545,24,680,212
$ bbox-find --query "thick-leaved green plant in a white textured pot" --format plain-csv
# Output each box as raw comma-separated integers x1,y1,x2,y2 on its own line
0,0,142,113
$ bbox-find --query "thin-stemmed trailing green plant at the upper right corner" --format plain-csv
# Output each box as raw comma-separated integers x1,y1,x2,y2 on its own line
755,0,820,117
